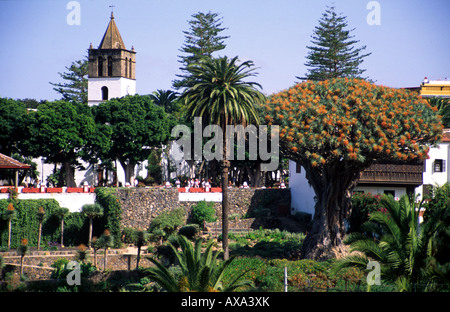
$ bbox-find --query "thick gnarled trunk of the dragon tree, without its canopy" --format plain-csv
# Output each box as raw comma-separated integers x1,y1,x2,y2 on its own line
301,166,358,261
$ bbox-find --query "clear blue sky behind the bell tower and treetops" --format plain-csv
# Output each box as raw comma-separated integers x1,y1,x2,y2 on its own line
0,0,450,100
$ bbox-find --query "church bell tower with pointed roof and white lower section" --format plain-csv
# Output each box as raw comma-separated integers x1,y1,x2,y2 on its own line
88,12,136,105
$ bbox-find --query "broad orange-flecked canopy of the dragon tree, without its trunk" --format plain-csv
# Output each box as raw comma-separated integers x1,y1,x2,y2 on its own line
265,78,442,169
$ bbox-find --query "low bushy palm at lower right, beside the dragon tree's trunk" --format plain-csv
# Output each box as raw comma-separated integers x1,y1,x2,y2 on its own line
335,195,436,291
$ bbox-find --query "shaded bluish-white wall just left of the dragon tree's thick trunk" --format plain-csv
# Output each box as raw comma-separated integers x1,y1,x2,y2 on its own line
289,160,316,217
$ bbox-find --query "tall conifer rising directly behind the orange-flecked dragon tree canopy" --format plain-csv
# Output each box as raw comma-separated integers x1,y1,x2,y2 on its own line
297,7,371,81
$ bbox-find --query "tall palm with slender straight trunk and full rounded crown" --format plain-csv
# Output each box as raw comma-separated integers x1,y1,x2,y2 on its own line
181,57,264,260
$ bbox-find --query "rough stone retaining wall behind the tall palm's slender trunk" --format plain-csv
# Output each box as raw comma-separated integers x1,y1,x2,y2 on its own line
117,188,291,229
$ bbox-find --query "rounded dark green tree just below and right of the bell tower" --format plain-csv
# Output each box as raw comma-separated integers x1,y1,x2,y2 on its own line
92,95,175,182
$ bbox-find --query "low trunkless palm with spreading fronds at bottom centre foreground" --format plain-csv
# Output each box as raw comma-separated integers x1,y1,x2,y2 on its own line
145,235,250,292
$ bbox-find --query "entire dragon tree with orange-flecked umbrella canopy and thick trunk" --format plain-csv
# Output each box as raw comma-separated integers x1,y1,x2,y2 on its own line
265,78,442,259
